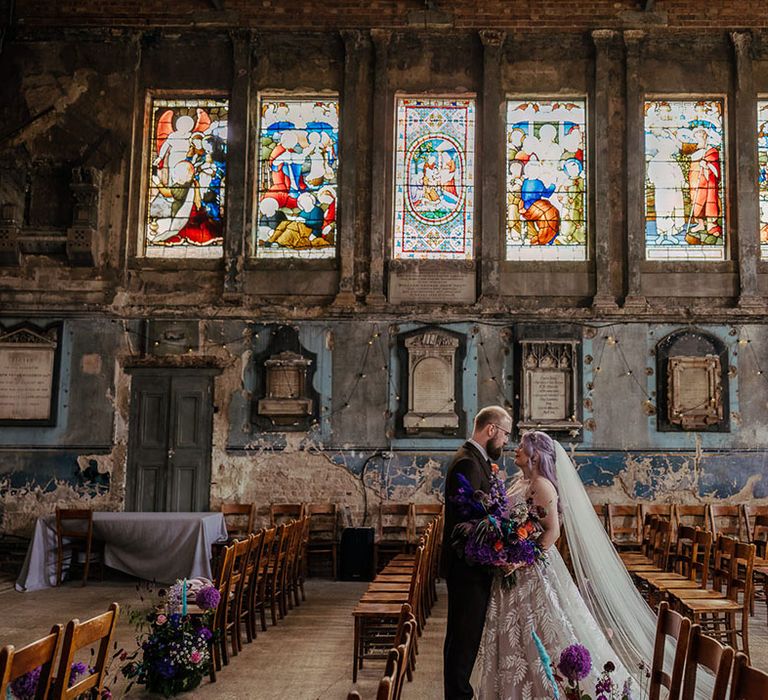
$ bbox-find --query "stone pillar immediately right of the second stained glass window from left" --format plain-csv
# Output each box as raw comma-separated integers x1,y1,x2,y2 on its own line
334,29,369,307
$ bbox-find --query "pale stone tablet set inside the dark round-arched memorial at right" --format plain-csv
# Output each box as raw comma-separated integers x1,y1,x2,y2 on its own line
667,355,723,430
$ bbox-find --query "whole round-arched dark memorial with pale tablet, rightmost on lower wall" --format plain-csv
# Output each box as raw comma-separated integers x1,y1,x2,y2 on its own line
656,328,730,432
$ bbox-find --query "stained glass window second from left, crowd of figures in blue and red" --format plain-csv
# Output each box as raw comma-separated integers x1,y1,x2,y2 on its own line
255,97,339,260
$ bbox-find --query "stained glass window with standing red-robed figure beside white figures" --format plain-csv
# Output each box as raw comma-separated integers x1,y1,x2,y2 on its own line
645,99,726,260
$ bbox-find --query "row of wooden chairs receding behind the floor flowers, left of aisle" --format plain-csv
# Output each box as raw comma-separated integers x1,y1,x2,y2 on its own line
211,516,310,681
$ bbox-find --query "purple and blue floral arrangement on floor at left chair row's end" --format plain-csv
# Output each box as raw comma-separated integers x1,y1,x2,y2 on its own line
121,579,221,697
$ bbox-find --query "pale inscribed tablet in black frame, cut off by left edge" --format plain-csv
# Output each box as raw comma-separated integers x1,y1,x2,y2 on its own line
0,326,58,425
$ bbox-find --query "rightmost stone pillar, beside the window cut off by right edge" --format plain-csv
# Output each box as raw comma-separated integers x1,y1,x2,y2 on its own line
729,32,765,309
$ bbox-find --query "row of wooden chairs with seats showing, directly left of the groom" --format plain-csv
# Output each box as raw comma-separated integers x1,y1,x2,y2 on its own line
352,514,443,682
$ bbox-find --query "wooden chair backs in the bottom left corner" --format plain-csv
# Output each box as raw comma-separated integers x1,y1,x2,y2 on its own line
0,603,120,700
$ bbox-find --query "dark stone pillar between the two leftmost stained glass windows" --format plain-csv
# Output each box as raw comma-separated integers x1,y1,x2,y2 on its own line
224,30,253,302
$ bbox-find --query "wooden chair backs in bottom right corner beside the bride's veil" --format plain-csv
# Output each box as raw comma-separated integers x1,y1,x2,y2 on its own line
648,602,768,700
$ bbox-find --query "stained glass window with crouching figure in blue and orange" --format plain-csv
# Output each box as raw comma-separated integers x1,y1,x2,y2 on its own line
506,98,587,260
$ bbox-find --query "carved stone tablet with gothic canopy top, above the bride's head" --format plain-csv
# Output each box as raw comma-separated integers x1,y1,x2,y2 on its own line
517,340,581,431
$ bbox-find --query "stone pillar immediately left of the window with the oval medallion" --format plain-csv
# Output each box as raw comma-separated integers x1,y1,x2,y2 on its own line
366,29,392,306
